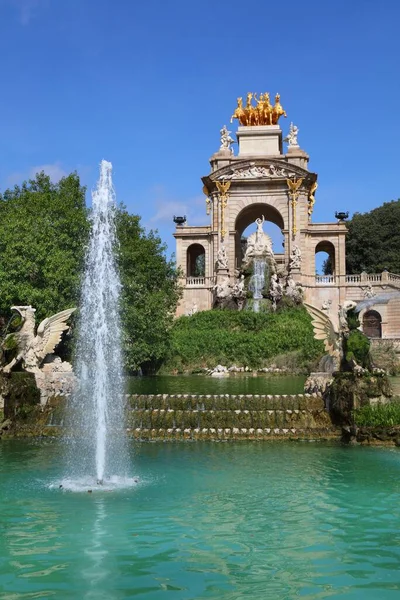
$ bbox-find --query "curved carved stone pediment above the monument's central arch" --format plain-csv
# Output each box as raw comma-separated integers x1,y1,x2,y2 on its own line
202,158,317,192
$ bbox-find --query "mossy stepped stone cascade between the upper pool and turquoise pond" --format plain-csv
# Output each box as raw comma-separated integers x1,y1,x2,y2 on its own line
127,394,338,440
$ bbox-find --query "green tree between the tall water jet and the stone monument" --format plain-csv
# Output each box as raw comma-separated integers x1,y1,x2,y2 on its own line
117,208,180,372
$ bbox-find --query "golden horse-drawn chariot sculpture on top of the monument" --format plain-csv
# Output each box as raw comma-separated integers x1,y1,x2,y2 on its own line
231,92,287,125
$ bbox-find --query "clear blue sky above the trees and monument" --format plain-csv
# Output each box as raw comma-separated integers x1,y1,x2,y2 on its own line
0,0,400,251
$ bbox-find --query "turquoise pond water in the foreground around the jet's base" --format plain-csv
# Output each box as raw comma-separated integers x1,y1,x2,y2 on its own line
0,440,400,600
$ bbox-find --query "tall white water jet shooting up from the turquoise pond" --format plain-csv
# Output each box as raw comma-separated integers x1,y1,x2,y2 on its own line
64,160,128,487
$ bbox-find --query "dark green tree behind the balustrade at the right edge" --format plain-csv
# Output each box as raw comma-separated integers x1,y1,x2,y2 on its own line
346,200,400,274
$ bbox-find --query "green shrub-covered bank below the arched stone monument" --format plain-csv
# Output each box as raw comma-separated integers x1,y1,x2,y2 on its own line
164,307,323,370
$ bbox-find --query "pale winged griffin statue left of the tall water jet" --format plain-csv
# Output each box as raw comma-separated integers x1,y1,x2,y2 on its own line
0,306,76,373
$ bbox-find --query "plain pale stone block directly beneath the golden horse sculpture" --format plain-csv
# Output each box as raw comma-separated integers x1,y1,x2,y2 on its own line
237,125,282,158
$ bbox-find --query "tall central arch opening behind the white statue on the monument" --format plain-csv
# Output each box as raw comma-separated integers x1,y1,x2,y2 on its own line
235,202,285,268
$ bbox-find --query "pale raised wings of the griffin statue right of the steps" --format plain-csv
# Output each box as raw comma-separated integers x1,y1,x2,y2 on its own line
304,301,357,371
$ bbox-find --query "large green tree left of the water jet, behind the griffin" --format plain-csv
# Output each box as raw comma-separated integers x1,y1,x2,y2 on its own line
0,172,89,321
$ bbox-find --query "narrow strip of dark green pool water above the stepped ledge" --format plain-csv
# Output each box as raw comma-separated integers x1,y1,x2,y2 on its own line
128,374,306,394
